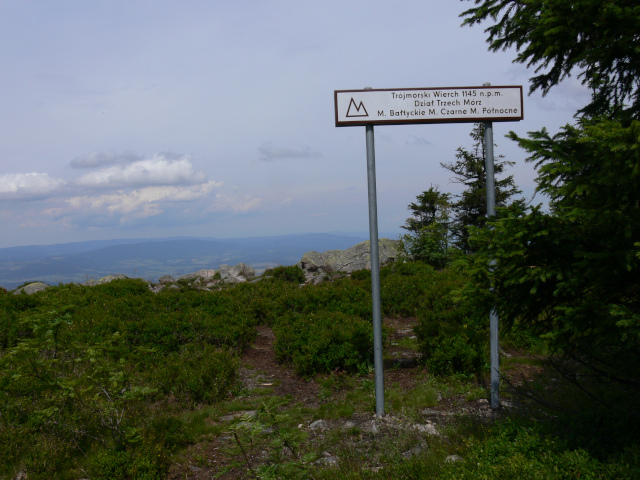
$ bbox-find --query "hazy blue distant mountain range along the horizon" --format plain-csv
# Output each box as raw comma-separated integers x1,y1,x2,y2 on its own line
0,233,396,289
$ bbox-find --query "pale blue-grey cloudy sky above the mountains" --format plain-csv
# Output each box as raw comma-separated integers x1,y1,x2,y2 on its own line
0,0,588,247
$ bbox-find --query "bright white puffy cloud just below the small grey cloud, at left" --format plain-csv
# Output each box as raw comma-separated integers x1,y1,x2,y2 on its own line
76,155,207,188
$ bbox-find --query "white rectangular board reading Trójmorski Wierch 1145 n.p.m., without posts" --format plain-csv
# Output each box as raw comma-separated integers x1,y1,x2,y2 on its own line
334,85,524,127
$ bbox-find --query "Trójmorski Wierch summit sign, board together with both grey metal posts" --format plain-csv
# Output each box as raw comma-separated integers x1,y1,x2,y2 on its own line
333,83,524,417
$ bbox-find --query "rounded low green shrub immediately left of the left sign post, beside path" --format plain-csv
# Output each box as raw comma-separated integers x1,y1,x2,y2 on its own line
274,312,373,376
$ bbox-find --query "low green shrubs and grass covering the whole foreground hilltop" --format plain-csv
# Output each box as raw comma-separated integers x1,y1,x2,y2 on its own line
0,262,640,480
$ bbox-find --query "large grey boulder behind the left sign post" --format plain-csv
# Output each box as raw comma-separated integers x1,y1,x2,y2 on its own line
298,238,400,273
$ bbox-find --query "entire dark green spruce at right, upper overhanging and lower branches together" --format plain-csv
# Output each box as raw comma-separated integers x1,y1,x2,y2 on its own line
463,0,640,400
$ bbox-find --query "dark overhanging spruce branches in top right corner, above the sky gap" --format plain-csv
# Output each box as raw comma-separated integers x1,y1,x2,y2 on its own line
462,0,640,117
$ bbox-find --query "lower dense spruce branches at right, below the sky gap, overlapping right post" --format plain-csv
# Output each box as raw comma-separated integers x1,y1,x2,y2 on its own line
468,119,640,389
